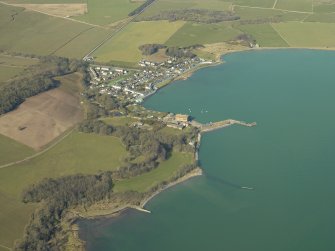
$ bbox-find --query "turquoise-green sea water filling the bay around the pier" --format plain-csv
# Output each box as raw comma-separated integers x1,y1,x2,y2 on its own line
81,49,335,251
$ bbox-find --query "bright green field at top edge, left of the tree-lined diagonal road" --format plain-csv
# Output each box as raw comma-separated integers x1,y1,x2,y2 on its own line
74,0,143,25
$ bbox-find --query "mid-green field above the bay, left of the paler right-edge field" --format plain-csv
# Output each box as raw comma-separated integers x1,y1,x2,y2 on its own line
239,24,288,47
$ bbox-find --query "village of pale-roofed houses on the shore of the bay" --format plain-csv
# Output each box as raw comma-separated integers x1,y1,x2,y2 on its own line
90,57,211,103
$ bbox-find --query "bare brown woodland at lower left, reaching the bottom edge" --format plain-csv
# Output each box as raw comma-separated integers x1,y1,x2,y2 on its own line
15,172,113,251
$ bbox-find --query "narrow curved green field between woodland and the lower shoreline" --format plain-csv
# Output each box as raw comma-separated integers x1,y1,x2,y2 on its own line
114,152,193,192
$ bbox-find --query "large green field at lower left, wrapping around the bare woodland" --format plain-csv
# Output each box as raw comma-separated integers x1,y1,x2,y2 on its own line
0,132,127,247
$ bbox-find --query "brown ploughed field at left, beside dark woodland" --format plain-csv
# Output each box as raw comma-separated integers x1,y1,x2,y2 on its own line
0,74,84,150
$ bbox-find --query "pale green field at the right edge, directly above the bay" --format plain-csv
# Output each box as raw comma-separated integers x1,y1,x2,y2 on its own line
272,22,335,48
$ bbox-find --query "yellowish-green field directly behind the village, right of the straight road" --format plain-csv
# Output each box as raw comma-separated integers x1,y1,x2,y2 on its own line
93,21,185,62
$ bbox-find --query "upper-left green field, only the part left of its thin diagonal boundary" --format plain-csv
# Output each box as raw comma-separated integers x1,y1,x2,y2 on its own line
0,4,98,55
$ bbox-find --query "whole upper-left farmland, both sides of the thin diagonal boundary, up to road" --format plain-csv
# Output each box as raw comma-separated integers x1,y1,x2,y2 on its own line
0,4,110,58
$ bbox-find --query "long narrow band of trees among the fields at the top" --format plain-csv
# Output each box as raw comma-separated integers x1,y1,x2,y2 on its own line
137,9,240,23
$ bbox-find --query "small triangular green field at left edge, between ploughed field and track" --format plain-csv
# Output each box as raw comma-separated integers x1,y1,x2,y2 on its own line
0,134,35,166
